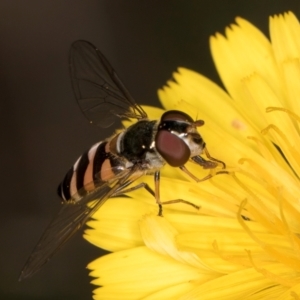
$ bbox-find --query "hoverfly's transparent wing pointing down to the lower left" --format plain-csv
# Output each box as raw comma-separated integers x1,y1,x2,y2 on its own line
19,170,134,280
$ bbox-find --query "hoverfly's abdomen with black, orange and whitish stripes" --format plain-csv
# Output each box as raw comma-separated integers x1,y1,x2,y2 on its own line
57,141,122,200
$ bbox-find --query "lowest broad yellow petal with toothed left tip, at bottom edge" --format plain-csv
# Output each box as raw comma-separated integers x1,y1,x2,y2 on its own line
88,247,215,300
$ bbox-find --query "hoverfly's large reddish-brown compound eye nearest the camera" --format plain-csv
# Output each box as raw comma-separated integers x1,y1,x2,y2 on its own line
155,130,191,167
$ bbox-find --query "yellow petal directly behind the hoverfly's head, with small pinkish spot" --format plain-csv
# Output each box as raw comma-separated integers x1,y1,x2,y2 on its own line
158,68,256,143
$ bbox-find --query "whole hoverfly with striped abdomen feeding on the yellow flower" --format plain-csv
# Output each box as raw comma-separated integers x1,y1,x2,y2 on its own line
20,41,225,280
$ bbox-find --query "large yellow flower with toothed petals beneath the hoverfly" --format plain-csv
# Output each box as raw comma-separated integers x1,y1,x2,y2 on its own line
85,12,300,300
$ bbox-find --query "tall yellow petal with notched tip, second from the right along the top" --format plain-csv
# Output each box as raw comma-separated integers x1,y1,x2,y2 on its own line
210,18,285,123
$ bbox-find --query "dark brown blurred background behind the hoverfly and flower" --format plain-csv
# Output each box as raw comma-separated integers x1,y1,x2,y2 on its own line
0,0,300,300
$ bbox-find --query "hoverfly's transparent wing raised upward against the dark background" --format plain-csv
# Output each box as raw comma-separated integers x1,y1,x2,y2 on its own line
70,41,147,128
